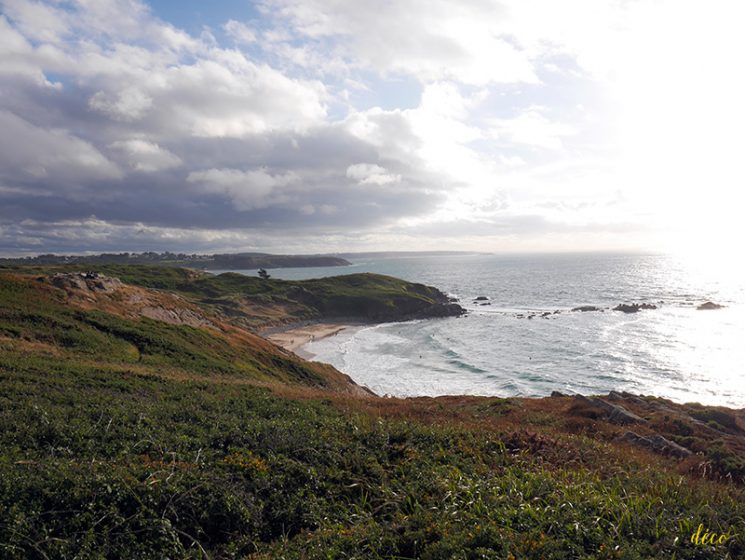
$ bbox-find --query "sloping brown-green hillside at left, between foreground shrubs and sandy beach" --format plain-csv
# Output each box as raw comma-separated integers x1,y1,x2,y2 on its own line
0,274,358,387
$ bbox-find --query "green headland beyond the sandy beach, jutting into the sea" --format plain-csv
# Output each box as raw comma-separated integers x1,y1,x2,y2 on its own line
0,265,463,327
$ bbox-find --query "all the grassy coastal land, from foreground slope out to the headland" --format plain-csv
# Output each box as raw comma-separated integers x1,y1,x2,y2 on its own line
0,266,745,559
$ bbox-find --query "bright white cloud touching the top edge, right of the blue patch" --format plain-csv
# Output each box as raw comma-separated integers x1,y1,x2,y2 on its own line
264,0,539,85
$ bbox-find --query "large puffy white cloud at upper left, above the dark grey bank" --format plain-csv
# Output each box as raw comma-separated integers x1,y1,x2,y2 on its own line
0,0,327,138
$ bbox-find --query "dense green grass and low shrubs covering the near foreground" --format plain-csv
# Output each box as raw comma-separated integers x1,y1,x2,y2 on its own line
0,365,745,558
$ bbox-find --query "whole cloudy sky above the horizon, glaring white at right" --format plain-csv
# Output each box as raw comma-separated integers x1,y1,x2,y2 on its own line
0,0,745,256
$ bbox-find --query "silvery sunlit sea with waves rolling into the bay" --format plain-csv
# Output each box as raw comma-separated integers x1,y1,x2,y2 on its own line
225,255,745,408
